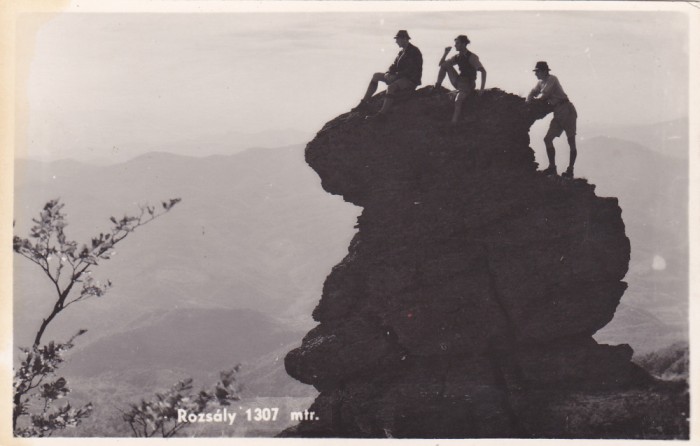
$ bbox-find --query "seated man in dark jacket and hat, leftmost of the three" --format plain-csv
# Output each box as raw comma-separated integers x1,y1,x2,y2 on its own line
357,29,423,117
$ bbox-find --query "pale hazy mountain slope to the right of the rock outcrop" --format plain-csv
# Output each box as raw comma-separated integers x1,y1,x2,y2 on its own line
577,137,689,325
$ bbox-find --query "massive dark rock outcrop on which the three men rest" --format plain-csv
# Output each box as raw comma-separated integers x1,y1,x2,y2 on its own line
282,87,687,438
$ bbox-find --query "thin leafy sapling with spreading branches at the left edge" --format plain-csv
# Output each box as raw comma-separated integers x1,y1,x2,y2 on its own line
12,198,180,437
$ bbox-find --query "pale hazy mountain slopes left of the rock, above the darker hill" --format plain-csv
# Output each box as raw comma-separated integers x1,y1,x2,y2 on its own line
15,146,356,345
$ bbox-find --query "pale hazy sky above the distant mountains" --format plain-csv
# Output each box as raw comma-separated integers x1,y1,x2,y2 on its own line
17,5,689,159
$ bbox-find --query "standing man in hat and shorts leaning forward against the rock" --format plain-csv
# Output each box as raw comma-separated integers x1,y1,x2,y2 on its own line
527,61,578,178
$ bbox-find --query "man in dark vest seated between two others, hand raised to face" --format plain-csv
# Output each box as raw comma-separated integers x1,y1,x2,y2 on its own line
435,35,486,124
